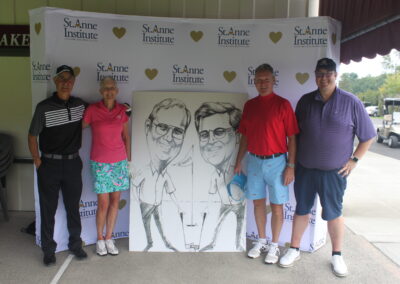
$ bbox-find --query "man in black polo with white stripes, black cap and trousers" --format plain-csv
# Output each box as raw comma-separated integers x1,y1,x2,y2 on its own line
28,65,87,266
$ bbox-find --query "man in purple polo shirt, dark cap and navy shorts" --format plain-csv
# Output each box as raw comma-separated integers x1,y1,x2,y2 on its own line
279,58,376,277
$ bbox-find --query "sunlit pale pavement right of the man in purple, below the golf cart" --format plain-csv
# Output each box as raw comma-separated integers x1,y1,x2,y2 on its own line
343,148,400,265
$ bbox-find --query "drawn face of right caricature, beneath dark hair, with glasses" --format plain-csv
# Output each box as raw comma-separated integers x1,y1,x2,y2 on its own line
199,113,236,167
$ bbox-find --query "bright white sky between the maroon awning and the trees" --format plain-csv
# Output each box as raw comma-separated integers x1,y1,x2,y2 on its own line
339,50,398,78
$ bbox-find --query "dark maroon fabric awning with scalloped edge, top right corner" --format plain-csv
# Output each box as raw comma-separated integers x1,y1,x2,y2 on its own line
319,0,400,64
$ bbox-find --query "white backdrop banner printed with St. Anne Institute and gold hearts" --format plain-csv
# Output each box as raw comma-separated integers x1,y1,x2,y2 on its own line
30,8,341,251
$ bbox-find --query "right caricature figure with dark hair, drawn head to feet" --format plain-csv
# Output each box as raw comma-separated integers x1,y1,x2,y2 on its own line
194,102,245,251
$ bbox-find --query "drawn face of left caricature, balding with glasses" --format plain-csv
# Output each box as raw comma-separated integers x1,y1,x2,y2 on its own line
146,107,186,163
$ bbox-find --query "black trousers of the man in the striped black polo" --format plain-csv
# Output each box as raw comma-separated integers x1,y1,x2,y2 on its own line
37,157,82,254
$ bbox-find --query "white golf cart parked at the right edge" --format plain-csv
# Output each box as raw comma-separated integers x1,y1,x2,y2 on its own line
376,98,400,148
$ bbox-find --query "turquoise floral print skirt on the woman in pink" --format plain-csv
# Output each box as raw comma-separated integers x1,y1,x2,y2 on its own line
90,160,129,194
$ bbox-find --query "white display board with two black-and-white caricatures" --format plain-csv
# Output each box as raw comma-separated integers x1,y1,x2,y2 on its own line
129,92,247,251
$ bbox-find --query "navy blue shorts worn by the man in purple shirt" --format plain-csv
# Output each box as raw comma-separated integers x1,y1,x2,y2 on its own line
294,163,347,221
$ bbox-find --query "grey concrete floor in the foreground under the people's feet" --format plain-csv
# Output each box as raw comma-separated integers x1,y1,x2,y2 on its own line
0,212,400,284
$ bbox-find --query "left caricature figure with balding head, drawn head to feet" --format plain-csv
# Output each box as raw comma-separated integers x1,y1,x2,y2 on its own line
132,98,191,251
